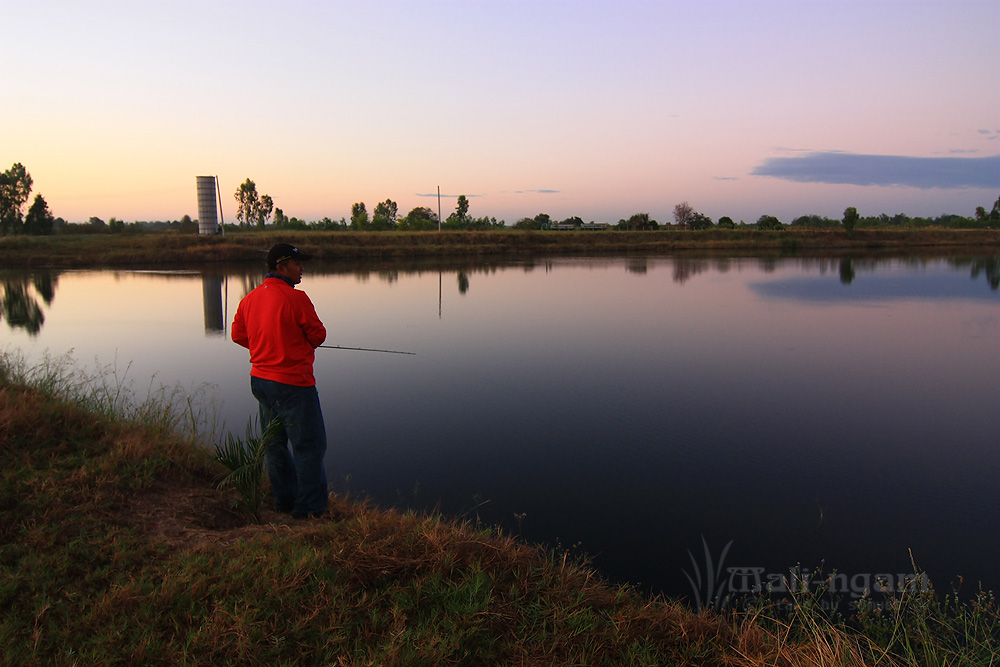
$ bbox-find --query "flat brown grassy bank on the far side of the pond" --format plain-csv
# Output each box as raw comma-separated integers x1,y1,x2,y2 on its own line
0,228,1000,267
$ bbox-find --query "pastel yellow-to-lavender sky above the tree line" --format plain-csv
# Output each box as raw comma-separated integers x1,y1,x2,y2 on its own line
0,0,1000,224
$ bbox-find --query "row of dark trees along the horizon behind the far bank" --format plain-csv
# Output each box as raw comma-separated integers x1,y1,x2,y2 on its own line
0,163,1000,236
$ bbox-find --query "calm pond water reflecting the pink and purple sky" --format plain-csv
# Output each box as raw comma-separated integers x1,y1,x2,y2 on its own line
0,256,1000,603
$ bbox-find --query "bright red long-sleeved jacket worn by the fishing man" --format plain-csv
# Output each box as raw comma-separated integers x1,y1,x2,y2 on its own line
232,277,326,387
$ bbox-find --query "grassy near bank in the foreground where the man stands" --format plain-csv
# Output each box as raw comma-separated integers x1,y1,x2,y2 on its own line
0,355,1000,666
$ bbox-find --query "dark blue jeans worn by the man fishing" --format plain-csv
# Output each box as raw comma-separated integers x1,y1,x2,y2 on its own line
250,375,328,516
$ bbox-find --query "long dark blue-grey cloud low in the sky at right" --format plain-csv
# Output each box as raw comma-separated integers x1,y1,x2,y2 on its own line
750,151,1000,189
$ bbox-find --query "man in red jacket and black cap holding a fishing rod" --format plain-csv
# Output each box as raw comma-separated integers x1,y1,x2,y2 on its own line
232,243,328,518
